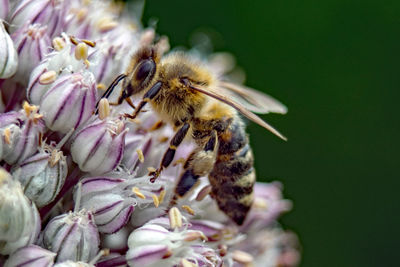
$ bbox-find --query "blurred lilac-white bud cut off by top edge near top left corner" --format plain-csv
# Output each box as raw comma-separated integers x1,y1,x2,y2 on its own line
10,0,68,36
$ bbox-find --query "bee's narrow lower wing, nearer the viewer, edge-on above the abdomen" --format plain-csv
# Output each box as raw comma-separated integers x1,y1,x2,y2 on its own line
189,85,287,141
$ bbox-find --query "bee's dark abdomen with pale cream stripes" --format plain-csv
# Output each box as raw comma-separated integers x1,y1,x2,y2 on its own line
209,117,256,225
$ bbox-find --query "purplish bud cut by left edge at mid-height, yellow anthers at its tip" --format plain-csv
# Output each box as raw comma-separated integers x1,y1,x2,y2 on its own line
0,102,44,164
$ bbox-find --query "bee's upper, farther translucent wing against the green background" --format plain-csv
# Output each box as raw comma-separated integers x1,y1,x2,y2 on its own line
218,81,287,114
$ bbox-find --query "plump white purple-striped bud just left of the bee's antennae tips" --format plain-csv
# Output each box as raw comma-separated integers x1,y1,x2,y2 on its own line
40,71,97,133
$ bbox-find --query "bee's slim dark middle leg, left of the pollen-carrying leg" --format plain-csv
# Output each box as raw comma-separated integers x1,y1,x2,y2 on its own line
149,122,190,183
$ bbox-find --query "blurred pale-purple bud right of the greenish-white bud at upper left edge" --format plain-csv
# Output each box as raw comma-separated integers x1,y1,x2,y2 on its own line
11,23,51,85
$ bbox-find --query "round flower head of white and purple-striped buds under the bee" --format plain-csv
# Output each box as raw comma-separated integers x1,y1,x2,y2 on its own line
0,0,299,267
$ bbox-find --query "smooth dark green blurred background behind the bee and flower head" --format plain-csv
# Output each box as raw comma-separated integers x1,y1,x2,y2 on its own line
138,0,400,266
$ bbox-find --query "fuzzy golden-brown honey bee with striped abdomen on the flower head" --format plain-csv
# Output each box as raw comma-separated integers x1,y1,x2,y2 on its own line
103,46,286,225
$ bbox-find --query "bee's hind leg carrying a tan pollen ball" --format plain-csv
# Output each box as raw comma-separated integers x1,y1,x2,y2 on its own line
169,131,218,208
